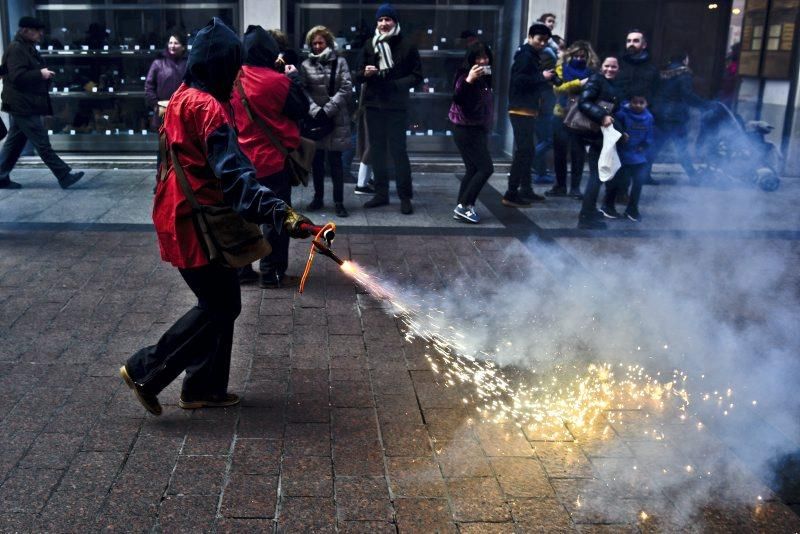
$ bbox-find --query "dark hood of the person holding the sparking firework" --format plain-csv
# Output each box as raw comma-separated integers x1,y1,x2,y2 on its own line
183,17,242,102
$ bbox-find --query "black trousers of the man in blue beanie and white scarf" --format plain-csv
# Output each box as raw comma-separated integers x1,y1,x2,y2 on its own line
367,108,414,199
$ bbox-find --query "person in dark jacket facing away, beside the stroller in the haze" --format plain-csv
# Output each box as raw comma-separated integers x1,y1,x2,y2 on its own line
650,52,707,185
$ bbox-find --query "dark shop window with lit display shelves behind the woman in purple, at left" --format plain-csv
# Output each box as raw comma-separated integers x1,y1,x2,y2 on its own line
36,0,238,152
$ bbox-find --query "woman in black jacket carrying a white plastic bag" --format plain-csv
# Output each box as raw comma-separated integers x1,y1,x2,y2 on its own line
578,56,622,230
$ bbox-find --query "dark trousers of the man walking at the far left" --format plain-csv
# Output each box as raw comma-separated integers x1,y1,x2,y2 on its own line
0,113,72,182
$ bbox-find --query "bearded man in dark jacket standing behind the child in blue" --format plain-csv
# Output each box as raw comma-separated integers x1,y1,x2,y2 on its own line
617,29,660,185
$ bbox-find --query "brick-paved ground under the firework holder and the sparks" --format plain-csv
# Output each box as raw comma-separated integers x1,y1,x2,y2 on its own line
0,169,800,533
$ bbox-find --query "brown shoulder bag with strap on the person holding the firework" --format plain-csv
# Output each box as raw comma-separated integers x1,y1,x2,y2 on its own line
159,132,272,269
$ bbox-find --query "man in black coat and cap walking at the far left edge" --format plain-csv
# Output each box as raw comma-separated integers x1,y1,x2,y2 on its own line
0,17,83,189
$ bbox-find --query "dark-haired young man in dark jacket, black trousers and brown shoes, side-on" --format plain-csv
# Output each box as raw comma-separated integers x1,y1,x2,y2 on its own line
502,23,553,208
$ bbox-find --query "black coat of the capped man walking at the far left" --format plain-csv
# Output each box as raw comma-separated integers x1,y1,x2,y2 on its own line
2,33,53,115
